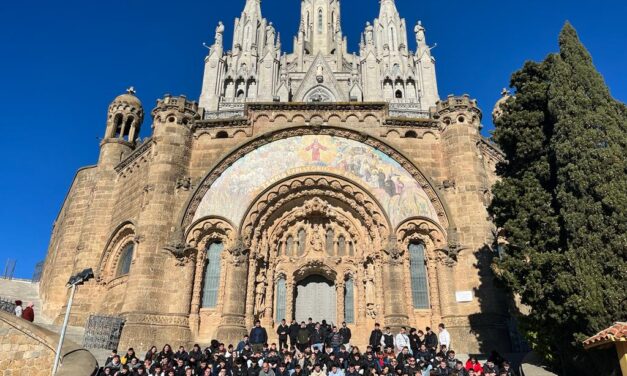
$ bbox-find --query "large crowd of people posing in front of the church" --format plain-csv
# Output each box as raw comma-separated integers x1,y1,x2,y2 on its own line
99,319,515,376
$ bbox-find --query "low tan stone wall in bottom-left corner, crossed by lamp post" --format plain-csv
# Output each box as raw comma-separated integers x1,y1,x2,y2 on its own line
0,312,98,376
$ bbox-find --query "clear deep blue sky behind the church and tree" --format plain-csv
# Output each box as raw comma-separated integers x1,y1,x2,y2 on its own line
0,0,627,280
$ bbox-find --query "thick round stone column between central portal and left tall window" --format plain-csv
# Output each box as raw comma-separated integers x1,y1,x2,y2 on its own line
216,239,249,343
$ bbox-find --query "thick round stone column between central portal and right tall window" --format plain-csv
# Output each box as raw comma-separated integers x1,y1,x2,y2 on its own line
383,236,409,332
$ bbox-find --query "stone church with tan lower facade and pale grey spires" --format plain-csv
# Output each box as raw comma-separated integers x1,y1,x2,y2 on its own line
41,0,510,353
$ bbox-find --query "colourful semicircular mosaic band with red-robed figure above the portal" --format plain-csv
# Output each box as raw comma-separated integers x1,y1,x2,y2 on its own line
194,135,438,226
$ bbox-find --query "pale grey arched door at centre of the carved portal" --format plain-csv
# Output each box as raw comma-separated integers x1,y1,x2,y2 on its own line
294,275,337,323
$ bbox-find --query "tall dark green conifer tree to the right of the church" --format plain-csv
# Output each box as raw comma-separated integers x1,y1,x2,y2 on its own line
490,24,627,374
